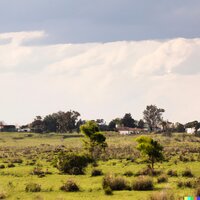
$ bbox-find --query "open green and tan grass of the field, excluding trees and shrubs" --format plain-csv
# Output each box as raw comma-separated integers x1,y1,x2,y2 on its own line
0,133,200,200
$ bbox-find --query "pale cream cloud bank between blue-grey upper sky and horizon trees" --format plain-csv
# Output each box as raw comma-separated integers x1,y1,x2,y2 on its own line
0,31,200,124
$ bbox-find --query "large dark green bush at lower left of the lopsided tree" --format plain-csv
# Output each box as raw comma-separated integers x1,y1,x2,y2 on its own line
56,152,91,175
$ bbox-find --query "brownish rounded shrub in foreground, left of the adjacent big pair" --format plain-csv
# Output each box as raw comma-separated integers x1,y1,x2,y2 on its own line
102,174,130,190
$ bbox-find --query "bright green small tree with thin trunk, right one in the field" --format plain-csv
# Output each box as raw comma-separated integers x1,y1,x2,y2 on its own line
136,136,164,171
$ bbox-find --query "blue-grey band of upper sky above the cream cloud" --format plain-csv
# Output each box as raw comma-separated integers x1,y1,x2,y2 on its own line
0,0,200,43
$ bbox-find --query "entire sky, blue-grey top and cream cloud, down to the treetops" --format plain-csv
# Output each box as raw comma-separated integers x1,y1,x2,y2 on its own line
0,0,200,124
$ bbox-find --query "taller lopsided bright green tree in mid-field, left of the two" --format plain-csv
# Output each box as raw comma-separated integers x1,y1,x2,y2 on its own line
80,121,107,161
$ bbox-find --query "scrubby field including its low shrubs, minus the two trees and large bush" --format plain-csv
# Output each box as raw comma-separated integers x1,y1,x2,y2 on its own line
0,132,200,200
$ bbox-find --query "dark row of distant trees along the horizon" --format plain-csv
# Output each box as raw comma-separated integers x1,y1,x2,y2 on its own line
23,105,200,133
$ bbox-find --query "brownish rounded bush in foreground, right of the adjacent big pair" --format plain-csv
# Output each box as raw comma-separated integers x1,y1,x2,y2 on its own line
132,176,154,190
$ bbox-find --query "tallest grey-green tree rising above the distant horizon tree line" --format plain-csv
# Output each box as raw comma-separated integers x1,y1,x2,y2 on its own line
143,105,165,131
